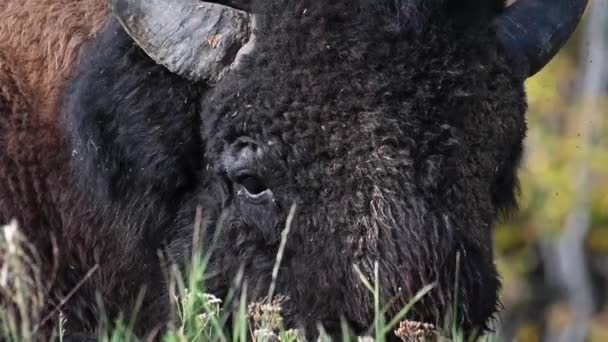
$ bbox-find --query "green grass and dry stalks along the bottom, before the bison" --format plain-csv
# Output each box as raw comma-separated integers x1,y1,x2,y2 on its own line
0,212,491,342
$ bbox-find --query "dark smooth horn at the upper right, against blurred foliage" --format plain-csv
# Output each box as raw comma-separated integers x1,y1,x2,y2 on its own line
496,0,588,77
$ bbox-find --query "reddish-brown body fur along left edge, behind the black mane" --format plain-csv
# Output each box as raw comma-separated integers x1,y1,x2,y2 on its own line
0,0,167,340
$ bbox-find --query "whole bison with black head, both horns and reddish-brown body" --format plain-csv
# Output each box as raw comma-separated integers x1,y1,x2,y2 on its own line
0,0,587,338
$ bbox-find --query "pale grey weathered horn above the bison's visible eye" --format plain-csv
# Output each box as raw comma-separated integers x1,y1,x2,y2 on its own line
112,0,251,83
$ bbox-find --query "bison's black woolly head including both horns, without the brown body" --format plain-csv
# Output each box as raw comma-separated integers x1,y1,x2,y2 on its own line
73,0,586,334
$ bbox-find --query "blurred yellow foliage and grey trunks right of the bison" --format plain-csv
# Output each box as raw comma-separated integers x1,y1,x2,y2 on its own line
495,0,608,342
